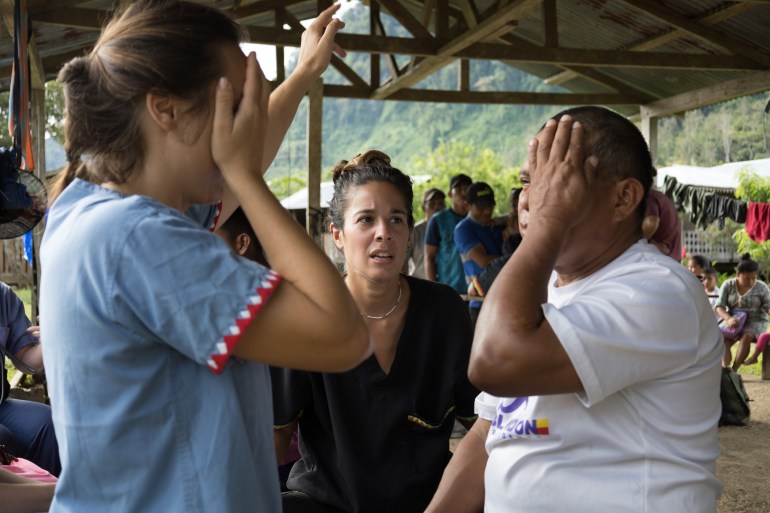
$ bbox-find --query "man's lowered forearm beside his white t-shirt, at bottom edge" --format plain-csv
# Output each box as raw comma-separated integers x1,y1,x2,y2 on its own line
425,419,490,513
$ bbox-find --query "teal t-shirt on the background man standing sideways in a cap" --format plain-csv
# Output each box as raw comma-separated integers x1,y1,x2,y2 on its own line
425,208,468,294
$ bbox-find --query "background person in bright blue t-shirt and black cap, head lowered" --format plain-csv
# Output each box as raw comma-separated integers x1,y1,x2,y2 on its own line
454,182,505,326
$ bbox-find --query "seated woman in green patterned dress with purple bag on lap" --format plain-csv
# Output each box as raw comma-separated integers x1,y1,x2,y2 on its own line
715,253,770,371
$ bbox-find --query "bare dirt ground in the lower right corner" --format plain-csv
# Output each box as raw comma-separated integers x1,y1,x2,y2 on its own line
717,375,770,513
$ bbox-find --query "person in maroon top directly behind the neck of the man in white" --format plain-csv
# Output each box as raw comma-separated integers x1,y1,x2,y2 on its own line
642,185,682,262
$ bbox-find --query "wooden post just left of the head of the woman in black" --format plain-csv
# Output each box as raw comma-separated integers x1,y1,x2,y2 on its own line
305,78,323,249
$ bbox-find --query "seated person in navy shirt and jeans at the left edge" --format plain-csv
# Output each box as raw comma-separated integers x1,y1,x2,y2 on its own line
0,282,61,476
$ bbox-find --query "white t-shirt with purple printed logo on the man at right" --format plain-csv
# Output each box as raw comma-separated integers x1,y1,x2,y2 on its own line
476,242,722,513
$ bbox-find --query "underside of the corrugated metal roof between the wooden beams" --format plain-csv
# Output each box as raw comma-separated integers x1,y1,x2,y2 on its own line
0,0,770,110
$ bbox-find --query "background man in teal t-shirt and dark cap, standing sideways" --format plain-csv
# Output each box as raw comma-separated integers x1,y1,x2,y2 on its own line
425,174,473,294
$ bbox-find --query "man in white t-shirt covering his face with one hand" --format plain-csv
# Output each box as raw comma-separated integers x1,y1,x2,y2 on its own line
427,107,722,513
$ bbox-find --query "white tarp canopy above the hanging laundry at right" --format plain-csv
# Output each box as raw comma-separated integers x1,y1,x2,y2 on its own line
656,159,770,190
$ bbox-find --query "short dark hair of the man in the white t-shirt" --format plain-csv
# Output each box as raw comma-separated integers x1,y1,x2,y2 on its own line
541,105,657,222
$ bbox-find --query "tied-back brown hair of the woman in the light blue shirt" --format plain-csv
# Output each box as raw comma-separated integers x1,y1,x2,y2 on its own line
51,0,245,201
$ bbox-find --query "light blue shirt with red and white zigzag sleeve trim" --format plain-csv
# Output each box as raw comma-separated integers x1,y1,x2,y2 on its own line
40,180,281,513
